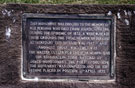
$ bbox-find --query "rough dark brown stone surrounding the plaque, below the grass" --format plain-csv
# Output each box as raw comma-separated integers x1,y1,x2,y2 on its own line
0,4,135,88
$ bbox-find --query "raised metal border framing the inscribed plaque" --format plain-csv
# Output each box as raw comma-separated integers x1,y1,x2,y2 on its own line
21,13,116,82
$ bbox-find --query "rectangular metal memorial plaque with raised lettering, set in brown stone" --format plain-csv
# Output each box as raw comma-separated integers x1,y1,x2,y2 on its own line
22,13,115,80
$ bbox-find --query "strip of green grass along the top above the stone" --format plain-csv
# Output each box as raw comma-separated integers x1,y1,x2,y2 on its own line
0,0,135,4
